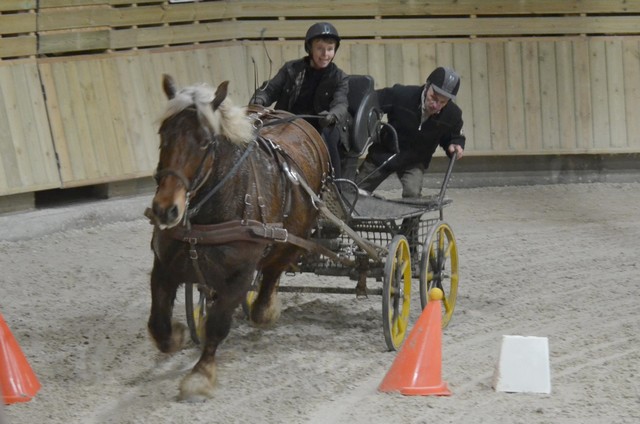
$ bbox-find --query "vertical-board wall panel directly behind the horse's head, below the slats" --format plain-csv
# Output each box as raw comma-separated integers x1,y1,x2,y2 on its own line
40,45,250,187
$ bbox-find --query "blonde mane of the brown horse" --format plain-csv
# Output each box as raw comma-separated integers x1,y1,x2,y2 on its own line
160,84,254,144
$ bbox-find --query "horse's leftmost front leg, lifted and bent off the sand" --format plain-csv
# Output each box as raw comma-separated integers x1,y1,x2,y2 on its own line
147,258,189,353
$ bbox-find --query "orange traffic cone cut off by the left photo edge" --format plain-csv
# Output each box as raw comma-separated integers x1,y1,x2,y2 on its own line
0,314,40,405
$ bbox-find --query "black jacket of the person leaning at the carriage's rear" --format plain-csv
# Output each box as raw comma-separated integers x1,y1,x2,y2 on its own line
368,84,465,171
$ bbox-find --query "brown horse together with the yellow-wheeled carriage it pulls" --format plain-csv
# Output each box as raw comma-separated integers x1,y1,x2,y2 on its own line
148,77,458,399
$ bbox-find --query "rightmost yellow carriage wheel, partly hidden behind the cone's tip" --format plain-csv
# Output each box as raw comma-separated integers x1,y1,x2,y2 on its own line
420,221,459,328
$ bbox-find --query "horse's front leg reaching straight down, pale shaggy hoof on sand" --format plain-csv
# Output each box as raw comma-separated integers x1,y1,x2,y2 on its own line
179,297,240,402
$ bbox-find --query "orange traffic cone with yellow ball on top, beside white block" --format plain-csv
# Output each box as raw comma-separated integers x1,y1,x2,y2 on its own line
378,288,451,396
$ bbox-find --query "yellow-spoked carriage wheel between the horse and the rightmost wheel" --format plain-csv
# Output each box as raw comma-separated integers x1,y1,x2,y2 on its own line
382,235,411,350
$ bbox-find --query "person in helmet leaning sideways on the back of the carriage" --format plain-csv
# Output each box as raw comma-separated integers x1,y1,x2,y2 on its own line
356,67,465,197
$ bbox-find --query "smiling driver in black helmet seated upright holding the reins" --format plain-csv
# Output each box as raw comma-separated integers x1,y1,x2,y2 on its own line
250,22,350,178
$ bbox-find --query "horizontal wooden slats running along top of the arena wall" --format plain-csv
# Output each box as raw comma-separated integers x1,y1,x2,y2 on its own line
20,0,640,57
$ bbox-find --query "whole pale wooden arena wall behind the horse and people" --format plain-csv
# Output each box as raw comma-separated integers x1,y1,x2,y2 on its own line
0,0,640,195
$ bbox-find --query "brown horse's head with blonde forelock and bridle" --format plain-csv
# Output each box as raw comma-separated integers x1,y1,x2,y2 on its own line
151,75,253,228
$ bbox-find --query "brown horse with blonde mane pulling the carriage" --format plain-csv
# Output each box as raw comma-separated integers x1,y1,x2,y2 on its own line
147,75,330,401
